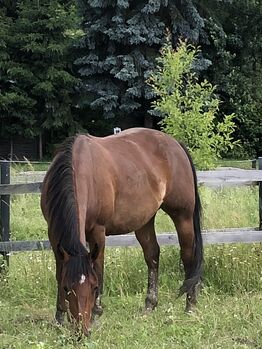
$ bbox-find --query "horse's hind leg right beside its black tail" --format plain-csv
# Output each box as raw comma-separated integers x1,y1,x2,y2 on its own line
167,210,200,312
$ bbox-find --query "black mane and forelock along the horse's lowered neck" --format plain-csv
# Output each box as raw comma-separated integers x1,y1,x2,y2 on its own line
47,136,92,283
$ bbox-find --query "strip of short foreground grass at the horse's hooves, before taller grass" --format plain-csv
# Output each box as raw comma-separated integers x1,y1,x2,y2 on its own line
0,292,262,349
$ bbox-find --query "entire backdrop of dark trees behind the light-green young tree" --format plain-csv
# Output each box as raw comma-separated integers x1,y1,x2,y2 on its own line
0,0,262,157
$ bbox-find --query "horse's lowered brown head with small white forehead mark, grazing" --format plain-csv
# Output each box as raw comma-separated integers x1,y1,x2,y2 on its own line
61,245,98,335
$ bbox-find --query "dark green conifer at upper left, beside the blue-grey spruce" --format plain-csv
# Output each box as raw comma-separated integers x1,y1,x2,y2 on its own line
0,0,78,143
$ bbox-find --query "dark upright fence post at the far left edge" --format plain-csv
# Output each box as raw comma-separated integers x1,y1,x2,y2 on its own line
0,160,10,265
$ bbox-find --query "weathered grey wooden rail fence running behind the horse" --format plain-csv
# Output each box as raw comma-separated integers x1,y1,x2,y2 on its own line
0,157,262,255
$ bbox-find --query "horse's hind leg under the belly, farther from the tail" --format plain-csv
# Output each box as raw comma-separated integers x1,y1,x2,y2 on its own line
135,217,160,310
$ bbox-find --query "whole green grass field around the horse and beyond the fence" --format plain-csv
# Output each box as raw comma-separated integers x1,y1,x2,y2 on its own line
0,179,262,349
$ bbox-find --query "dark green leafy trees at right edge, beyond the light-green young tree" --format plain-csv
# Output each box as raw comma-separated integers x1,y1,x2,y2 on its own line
203,0,262,156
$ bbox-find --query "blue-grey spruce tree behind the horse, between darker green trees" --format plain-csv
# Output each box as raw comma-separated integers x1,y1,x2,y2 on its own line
75,0,207,124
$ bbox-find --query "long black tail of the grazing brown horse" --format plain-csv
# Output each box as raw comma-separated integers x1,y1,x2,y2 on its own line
179,143,203,295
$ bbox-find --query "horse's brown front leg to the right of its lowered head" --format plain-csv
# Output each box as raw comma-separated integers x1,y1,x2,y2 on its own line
87,226,105,316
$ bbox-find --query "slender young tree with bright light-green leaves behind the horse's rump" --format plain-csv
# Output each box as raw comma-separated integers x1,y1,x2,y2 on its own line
149,42,235,169
